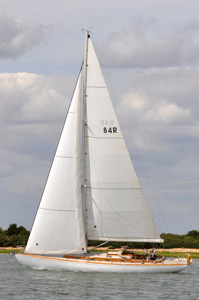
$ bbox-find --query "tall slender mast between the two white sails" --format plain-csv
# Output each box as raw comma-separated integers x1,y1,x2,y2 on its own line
81,30,90,245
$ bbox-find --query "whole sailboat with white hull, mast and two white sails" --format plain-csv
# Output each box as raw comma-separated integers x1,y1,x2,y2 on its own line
16,31,192,273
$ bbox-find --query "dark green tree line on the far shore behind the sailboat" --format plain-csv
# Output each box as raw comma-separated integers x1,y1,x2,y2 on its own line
0,223,199,249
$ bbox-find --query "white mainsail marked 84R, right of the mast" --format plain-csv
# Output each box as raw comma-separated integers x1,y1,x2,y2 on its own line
85,38,162,242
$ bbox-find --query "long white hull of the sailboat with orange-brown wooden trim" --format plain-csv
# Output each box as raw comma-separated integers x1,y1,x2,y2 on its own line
15,254,190,273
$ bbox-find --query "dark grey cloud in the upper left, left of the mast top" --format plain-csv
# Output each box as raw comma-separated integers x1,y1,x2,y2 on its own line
0,14,52,59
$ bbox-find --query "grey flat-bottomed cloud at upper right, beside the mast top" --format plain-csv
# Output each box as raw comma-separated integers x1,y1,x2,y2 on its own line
101,24,199,68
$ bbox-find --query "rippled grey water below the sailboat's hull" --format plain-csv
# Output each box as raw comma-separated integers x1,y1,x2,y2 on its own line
0,254,199,300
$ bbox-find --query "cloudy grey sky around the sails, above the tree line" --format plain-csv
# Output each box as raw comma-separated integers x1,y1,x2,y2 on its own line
0,0,199,234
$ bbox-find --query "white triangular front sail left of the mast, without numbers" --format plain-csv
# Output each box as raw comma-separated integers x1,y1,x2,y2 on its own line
25,72,86,254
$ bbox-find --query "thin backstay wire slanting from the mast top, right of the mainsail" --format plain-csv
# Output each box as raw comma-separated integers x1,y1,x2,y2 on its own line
92,35,169,232
